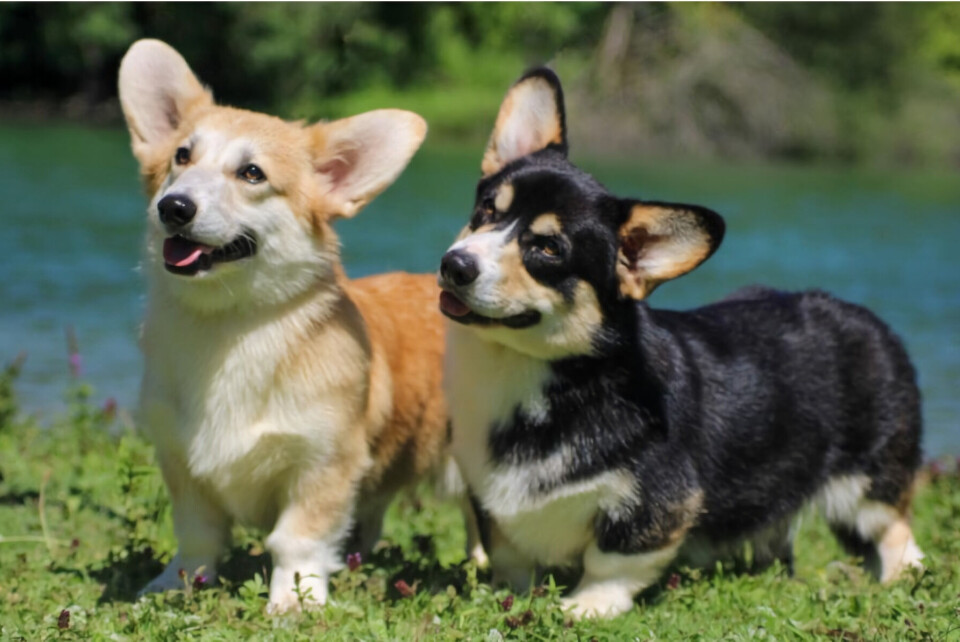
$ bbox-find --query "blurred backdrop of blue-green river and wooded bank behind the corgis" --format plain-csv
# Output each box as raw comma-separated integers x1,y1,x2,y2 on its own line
0,2,960,455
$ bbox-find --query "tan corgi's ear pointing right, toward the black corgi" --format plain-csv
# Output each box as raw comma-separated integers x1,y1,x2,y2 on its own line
309,109,427,218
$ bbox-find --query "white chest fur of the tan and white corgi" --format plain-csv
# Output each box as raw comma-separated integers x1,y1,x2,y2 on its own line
141,288,363,526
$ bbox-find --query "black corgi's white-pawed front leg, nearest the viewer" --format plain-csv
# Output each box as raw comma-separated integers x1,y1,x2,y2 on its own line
563,541,679,618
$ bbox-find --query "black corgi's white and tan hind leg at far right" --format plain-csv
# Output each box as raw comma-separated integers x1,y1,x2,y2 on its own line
819,475,923,583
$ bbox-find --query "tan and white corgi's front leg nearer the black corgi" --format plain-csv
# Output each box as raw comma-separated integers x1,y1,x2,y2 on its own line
266,456,363,613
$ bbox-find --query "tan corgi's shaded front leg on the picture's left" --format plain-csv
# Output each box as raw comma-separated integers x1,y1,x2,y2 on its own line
139,457,230,595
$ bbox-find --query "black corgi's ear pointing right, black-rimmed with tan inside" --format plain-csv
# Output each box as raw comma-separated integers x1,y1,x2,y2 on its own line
617,201,725,300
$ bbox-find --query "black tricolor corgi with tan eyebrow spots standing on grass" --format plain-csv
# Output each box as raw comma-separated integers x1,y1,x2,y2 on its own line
440,69,923,615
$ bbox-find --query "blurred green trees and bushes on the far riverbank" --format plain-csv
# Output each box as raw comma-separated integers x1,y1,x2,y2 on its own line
0,2,960,164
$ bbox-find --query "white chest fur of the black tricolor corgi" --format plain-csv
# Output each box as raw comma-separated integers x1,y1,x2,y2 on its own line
444,326,634,564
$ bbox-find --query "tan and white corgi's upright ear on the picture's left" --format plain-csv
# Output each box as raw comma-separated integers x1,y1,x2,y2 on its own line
118,39,213,162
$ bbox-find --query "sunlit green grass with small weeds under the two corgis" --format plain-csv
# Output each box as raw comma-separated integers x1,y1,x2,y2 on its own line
0,362,960,642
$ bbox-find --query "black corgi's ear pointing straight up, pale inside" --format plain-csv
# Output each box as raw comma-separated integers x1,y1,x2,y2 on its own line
480,67,567,176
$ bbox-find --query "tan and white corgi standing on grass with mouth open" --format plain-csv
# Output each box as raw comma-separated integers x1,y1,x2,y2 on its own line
119,40,464,611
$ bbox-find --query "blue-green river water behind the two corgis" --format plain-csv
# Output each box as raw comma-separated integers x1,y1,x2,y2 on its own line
0,126,960,454
